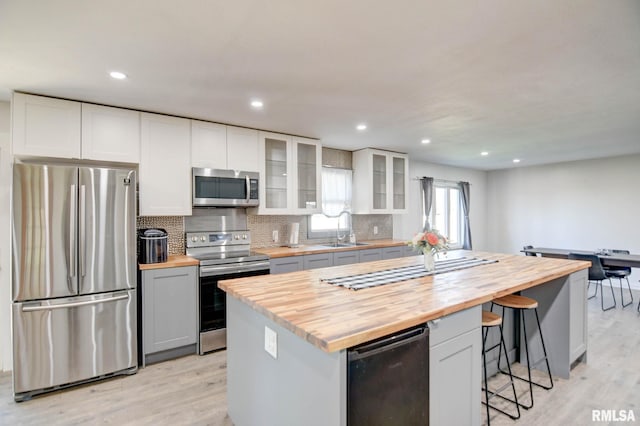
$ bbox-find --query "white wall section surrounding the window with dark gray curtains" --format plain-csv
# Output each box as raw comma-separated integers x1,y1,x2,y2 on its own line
393,160,487,250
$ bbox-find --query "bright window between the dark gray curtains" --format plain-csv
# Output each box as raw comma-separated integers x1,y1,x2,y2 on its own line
422,183,464,249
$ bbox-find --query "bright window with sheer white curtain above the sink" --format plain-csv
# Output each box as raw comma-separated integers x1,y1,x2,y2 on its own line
307,167,352,238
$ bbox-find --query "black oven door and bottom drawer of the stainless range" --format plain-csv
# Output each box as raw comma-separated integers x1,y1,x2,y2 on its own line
199,262,269,355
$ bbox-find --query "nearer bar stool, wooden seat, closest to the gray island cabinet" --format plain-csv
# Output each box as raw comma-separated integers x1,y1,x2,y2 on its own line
482,311,520,425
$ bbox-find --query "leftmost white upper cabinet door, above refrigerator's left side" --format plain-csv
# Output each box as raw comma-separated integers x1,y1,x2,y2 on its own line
11,93,81,158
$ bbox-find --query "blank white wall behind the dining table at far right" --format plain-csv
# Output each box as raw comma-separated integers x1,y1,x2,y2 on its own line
487,155,640,287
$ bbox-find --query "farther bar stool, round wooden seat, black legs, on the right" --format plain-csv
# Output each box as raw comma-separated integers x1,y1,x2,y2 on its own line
491,294,553,410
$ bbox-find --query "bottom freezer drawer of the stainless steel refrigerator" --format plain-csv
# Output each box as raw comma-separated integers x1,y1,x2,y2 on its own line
13,290,137,400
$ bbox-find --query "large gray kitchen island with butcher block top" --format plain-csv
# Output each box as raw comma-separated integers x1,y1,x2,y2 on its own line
219,251,589,426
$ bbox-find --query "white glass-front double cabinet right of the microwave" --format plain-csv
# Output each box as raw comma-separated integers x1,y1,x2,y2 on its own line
258,132,322,214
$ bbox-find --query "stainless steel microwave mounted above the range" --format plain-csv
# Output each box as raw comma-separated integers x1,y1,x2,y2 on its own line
192,167,259,207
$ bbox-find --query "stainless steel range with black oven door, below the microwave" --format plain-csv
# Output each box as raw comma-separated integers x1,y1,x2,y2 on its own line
185,208,269,355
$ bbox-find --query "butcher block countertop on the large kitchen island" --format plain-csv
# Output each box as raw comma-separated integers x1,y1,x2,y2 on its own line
218,251,590,352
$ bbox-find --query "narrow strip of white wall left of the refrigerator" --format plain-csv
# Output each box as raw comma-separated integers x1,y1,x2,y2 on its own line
0,102,11,371
